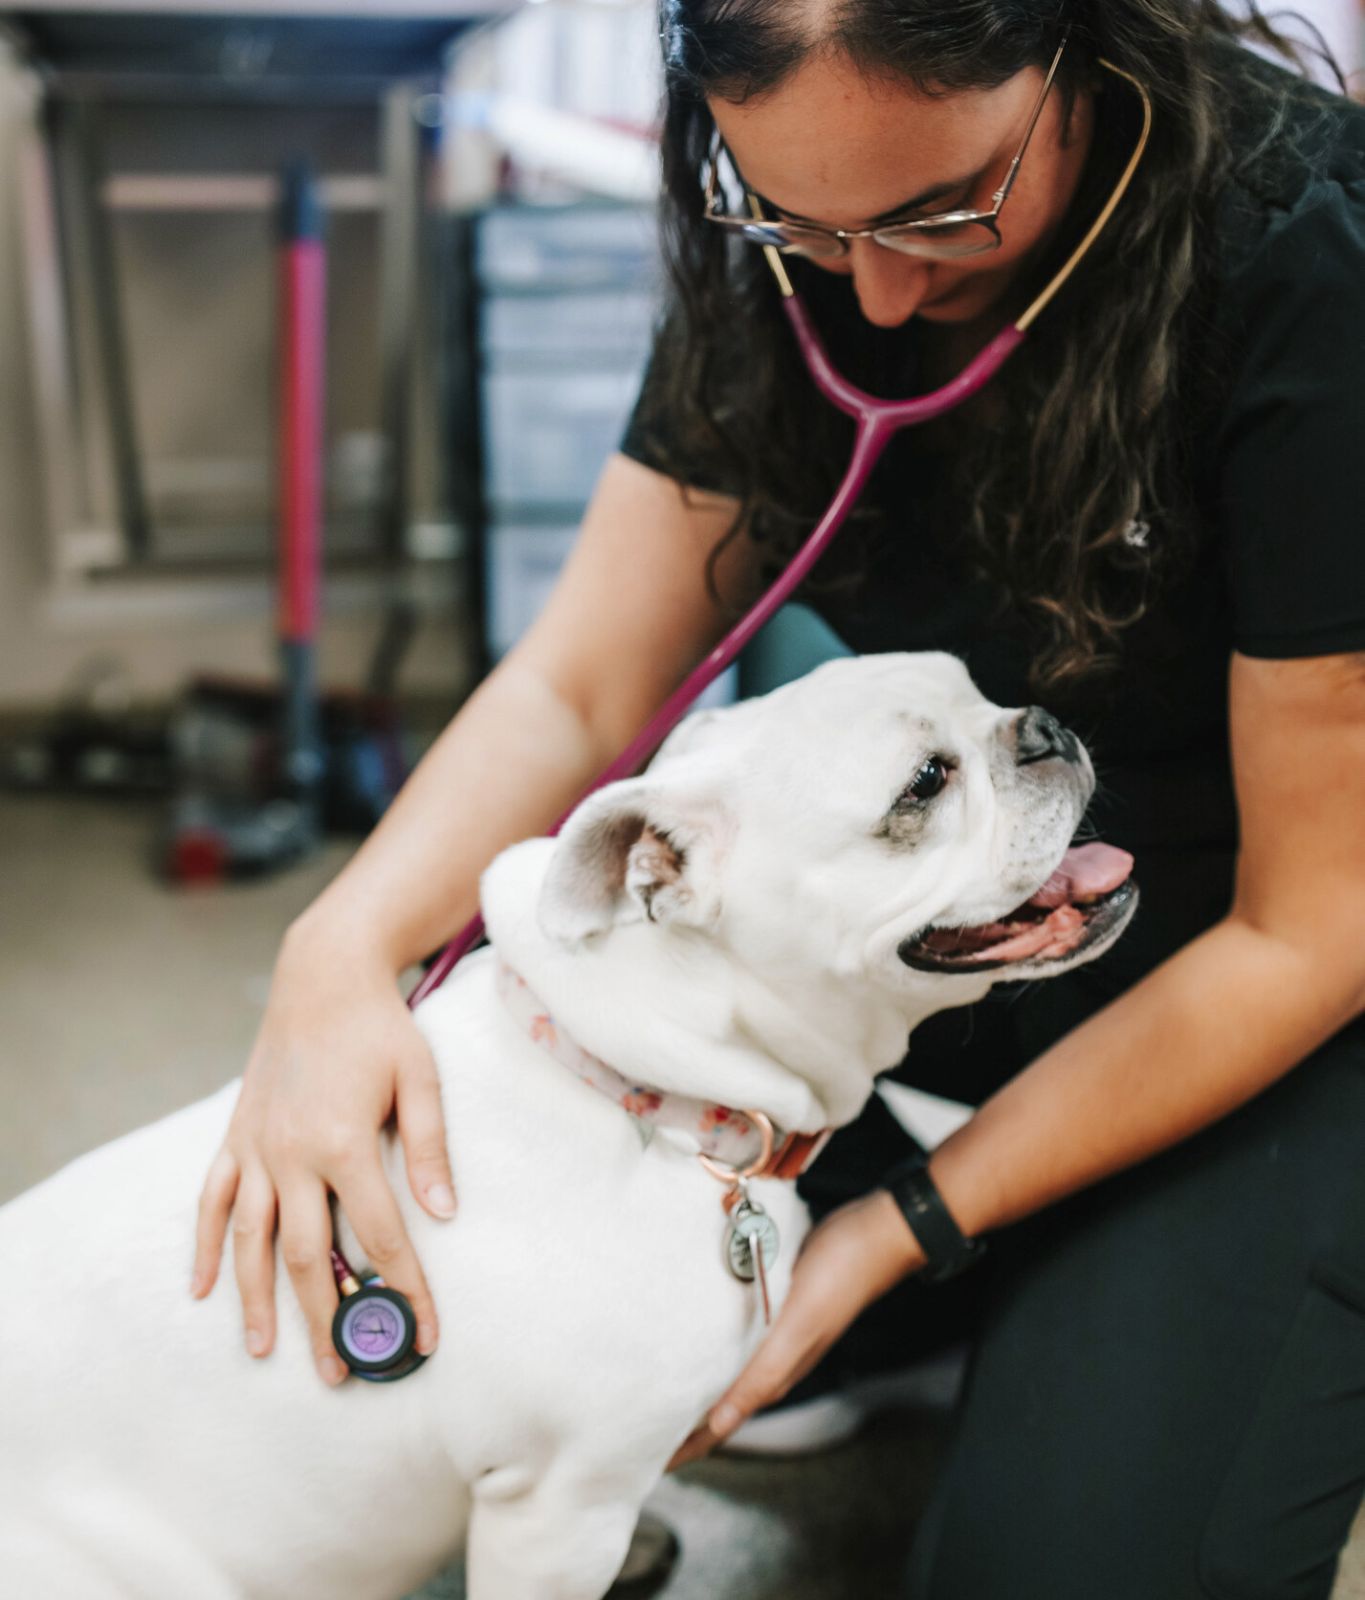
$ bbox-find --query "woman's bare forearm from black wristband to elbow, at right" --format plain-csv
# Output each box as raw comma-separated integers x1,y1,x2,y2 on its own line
911,917,1360,1235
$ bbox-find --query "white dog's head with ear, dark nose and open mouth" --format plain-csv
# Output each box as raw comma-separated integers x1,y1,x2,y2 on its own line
542,654,1136,992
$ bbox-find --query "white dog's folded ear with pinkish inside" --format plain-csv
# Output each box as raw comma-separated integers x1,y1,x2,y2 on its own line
539,778,725,941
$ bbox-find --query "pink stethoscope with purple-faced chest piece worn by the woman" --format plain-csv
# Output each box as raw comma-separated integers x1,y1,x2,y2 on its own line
331,58,1152,1381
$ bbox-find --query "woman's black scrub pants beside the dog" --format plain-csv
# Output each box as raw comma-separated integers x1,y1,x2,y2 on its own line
803,974,1365,1600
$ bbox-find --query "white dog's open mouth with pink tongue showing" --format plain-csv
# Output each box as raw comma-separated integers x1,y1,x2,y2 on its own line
899,845,1138,973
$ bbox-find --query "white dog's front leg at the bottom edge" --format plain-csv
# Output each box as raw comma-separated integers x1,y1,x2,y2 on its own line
467,1469,650,1600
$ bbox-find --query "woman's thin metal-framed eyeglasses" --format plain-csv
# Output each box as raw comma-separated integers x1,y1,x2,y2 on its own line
704,35,1067,261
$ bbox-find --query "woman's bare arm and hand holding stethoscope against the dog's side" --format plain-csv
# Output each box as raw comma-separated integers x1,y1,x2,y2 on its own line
180,456,759,1378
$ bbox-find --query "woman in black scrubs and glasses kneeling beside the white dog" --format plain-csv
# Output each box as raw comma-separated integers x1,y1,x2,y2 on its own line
188,0,1365,1600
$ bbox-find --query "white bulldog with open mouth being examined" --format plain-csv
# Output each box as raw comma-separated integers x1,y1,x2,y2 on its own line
0,654,1136,1600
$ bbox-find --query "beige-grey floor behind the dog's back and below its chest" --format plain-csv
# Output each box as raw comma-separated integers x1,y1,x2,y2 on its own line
0,797,1365,1600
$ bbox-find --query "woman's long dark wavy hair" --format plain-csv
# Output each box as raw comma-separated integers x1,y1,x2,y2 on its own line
642,0,1341,691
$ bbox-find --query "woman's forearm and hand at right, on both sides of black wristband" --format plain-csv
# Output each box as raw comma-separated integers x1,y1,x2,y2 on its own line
691,917,1365,1466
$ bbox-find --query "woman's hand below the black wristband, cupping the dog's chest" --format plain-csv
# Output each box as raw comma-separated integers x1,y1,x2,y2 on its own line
669,1189,925,1470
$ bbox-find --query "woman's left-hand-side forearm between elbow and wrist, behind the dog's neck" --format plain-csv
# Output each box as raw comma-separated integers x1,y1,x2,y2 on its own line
290,656,616,973
